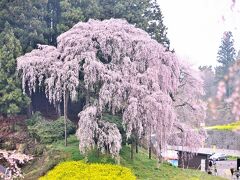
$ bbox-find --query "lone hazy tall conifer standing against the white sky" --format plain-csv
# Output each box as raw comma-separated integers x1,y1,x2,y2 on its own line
216,31,236,96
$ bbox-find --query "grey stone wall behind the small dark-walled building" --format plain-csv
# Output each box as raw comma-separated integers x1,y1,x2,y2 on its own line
205,130,240,150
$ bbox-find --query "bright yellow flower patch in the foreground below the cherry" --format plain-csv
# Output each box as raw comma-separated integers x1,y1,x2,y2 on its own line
40,161,136,180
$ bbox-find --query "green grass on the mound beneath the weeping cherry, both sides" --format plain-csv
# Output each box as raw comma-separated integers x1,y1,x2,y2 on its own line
23,136,225,180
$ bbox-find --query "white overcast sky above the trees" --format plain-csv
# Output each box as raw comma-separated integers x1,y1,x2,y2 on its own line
158,0,240,66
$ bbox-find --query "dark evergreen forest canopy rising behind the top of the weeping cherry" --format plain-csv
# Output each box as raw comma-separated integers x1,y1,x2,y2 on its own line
0,0,170,52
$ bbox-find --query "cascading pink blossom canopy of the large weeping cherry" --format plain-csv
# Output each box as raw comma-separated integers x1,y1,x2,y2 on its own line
18,19,204,158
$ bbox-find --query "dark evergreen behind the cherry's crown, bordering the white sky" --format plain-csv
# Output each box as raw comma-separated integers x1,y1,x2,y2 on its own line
90,0,170,49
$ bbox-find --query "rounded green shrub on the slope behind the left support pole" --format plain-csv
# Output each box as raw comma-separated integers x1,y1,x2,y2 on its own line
27,115,76,143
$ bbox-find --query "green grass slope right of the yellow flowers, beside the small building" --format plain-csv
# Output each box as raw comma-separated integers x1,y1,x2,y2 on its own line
121,147,223,180
